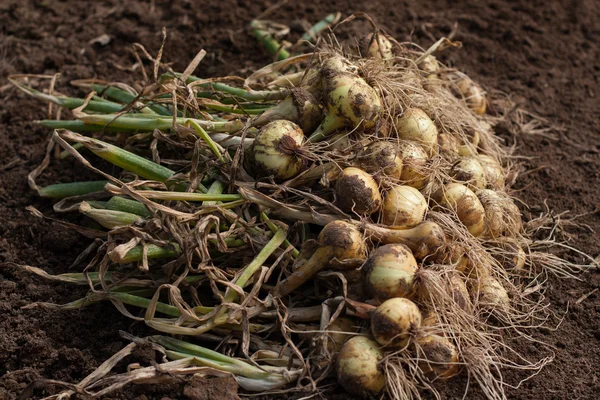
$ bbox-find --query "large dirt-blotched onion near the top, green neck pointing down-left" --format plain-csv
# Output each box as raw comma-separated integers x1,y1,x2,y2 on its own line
308,73,381,142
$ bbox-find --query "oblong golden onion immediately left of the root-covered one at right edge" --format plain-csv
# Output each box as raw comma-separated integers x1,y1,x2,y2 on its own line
436,183,485,236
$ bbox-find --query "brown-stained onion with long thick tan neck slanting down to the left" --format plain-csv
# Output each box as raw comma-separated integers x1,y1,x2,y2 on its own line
274,220,367,296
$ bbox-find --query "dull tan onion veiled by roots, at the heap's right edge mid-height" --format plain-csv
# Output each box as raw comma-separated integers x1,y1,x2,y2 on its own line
477,189,523,238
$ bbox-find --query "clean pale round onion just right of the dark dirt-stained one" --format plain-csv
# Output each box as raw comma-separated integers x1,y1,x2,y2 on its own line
381,185,427,229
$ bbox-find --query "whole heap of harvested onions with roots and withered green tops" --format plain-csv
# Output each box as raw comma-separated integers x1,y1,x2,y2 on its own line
11,13,592,398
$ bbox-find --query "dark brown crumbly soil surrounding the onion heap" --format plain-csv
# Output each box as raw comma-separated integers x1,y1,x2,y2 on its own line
0,0,600,399
